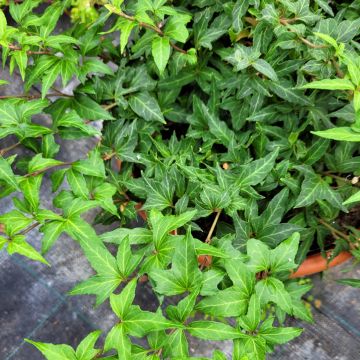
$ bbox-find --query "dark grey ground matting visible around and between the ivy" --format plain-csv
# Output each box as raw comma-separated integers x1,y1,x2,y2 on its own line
0,72,360,360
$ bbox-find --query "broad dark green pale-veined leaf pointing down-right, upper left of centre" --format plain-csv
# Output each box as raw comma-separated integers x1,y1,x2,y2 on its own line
129,92,165,124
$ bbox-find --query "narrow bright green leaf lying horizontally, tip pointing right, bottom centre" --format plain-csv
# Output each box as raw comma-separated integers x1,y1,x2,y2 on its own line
187,321,246,341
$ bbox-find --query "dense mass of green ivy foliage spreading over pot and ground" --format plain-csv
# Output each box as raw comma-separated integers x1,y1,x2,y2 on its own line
0,0,360,360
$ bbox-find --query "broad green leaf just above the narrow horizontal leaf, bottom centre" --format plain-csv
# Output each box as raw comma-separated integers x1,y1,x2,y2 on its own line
196,287,248,317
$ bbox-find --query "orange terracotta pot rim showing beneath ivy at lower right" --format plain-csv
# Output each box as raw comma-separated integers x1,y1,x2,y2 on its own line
290,250,352,279
